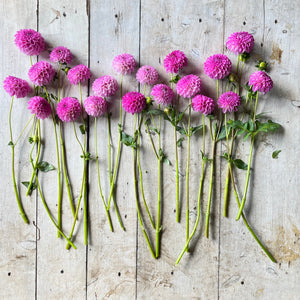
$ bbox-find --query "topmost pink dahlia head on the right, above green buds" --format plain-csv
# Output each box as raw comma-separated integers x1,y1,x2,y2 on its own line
226,31,254,55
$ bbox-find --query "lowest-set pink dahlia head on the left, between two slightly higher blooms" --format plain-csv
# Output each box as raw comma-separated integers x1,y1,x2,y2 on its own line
56,97,81,122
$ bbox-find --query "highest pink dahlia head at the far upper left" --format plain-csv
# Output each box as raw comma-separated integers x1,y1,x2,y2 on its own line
15,29,45,56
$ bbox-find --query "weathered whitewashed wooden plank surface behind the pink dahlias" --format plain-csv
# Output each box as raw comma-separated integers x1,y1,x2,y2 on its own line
0,0,300,299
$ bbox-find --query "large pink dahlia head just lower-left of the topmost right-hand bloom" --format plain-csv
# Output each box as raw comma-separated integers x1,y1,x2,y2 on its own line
203,54,231,79
